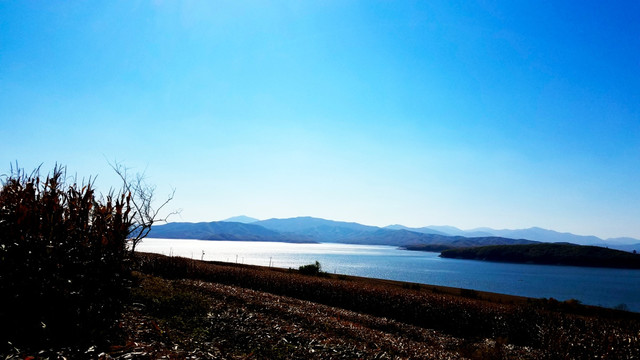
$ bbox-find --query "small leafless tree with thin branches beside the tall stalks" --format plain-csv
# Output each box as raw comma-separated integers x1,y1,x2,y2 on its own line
109,162,180,252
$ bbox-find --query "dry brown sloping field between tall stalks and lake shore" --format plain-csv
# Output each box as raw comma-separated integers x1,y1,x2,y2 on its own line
92,254,640,359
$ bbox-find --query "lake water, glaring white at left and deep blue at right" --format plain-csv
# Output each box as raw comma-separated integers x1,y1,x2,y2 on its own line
137,239,640,312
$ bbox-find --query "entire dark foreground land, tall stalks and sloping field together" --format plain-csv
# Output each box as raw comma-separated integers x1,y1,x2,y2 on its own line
0,165,640,359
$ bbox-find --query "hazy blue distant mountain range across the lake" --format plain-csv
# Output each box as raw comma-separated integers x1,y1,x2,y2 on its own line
149,216,640,251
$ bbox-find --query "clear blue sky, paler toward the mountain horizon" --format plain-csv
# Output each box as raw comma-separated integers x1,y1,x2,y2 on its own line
0,0,640,238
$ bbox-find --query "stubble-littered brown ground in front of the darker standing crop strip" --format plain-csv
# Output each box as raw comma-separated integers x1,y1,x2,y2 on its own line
110,276,540,359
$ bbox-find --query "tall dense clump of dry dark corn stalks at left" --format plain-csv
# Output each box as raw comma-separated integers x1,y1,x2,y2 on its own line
0,168,132,350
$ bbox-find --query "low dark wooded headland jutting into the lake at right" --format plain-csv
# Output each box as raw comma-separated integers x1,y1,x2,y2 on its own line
440,244,640,269
